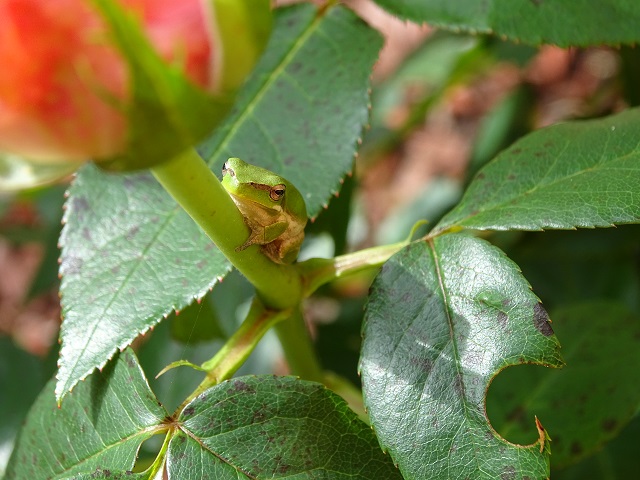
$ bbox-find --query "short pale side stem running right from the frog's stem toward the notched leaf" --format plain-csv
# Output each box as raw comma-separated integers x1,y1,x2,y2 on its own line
296,240,409,297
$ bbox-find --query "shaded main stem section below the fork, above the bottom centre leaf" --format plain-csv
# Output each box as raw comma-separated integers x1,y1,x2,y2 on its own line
275,309,324,383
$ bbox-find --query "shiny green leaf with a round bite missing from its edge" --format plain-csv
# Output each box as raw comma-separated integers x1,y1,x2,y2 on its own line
360,234,562,480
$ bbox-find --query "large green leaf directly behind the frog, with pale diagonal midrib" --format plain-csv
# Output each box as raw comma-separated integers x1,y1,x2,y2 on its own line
200,5,382,217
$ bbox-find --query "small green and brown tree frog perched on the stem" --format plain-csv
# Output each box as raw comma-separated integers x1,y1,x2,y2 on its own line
222,158,307,263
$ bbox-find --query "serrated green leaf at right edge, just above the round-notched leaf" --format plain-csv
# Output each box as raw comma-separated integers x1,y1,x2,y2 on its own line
434,109,640,233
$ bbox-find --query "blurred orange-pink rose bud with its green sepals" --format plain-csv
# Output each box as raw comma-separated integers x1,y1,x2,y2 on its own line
0,0,270,169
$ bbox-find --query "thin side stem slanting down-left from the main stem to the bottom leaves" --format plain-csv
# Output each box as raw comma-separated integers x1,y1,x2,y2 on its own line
177,298,291,412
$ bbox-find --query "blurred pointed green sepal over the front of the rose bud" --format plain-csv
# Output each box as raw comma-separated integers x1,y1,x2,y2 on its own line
93,0,233,171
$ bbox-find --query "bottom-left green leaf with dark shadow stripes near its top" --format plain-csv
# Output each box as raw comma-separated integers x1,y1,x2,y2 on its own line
5,350,167,480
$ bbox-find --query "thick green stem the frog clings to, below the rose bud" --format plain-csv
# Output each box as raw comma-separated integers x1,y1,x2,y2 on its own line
151,149,302,309
